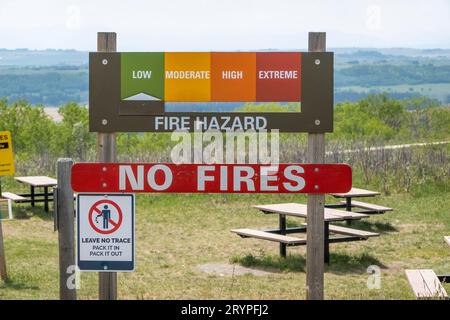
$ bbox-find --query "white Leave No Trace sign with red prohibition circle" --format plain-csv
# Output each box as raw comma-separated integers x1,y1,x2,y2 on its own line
77,194,135,272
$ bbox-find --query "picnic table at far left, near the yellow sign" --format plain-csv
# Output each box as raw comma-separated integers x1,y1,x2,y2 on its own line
5,176,57,212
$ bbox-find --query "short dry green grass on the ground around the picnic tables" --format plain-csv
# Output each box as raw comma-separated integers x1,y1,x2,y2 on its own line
0,188,450,299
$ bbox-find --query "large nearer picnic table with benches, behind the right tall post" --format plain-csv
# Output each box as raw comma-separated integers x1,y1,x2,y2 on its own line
231,203,379,263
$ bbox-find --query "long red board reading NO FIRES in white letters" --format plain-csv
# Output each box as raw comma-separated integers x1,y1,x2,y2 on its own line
72,163,352,193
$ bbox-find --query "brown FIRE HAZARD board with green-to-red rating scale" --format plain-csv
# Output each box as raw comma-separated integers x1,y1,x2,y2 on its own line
89,52,334,133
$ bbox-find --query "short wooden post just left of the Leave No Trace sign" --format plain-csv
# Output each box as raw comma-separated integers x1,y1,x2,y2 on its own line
56,158,77,300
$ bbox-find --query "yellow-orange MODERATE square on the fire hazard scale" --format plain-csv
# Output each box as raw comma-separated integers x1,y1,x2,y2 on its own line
164,52,211,102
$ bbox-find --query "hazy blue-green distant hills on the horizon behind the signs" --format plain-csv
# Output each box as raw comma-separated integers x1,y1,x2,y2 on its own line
0,48,450,106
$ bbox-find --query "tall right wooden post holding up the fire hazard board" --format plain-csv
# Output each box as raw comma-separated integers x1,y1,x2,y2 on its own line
306,32,326,300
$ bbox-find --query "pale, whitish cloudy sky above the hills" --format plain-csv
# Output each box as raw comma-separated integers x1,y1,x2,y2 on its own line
0,0,450,51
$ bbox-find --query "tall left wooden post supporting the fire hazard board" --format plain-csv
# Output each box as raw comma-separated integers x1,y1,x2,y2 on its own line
97,32,117,300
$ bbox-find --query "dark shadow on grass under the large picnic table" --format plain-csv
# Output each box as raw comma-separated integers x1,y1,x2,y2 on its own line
230,253,387,274
